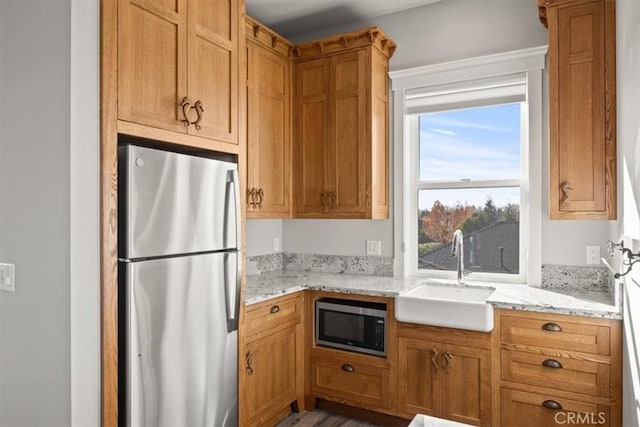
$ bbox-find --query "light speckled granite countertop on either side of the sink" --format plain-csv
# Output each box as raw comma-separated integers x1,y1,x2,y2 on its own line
245,270,622,319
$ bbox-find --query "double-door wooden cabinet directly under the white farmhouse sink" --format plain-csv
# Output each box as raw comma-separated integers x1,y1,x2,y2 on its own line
398,324,491,425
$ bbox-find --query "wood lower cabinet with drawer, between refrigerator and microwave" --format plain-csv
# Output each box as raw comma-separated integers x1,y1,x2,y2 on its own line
239,293,304,426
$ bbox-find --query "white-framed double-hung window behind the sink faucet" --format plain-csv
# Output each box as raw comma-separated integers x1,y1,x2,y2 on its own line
391,48,546,284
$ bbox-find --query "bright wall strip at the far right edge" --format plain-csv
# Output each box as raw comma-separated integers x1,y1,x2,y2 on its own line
617,0,640,426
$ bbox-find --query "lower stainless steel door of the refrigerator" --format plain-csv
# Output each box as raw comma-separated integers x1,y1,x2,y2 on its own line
126,253,238,427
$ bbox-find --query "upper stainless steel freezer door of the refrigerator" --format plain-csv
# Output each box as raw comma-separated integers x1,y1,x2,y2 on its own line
118,145,240,259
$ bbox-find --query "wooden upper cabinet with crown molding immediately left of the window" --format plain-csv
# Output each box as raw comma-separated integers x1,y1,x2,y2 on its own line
294,28,395,219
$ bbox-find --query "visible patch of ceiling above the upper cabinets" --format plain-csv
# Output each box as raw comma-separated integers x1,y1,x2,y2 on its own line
246,0,441,37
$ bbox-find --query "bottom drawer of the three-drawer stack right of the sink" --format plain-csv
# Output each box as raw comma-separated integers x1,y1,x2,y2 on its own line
500,388,612,427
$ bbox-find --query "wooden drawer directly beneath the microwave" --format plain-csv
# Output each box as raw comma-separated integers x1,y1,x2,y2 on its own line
311,356,389,408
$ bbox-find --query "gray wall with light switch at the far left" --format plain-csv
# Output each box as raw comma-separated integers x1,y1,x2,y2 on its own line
0,0,71,426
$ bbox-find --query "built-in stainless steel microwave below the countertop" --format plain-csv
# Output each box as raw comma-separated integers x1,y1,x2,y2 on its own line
315,298,387,356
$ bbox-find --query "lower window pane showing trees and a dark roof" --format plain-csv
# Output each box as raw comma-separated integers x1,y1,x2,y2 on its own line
418,187,520,274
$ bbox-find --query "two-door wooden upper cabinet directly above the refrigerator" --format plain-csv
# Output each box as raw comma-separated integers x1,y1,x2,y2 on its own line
117,0,243,144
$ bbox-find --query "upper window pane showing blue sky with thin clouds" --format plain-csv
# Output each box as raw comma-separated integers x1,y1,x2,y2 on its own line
419,103,521,181
